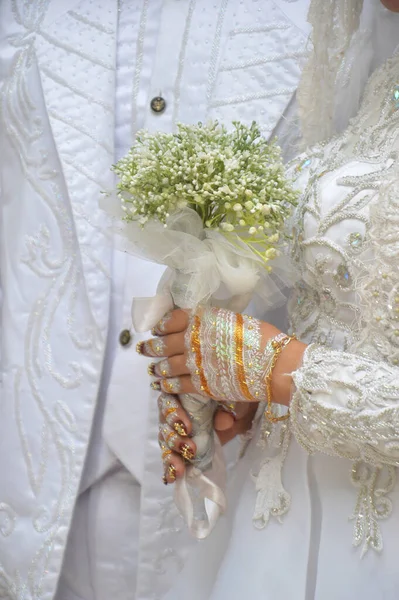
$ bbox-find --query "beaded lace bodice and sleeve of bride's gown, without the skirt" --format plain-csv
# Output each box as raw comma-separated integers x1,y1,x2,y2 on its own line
290,57,399,552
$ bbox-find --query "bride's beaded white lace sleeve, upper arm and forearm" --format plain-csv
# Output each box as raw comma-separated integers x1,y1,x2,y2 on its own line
290,167,399,466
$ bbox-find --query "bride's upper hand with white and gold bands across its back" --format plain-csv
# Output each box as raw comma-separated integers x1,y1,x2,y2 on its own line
137,309,305,405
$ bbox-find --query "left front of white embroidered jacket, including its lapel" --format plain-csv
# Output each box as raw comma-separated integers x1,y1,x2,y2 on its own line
0,0,117,600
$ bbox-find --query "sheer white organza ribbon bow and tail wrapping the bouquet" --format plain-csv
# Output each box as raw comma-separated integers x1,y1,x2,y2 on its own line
102,196,292,538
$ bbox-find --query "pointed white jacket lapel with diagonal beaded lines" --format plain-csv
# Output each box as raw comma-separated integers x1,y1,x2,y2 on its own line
36,0,117,336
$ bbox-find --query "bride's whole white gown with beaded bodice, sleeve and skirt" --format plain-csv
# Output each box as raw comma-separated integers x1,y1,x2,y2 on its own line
167,42,399,600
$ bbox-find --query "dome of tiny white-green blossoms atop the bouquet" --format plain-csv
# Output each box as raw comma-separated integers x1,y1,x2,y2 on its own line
113,122,298,270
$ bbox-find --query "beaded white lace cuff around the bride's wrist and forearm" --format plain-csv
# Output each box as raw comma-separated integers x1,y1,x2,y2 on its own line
290,344,399,466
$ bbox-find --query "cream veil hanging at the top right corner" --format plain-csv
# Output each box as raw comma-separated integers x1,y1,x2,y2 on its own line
297,0,399,146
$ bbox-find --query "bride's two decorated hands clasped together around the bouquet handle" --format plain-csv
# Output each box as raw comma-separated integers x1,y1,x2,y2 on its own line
137,308,304,483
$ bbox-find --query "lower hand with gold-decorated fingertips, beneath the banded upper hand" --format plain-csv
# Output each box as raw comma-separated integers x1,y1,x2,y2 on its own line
158,394,257,484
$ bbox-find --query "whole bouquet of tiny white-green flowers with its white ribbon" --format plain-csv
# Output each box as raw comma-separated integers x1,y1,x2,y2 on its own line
104,122,298,537
